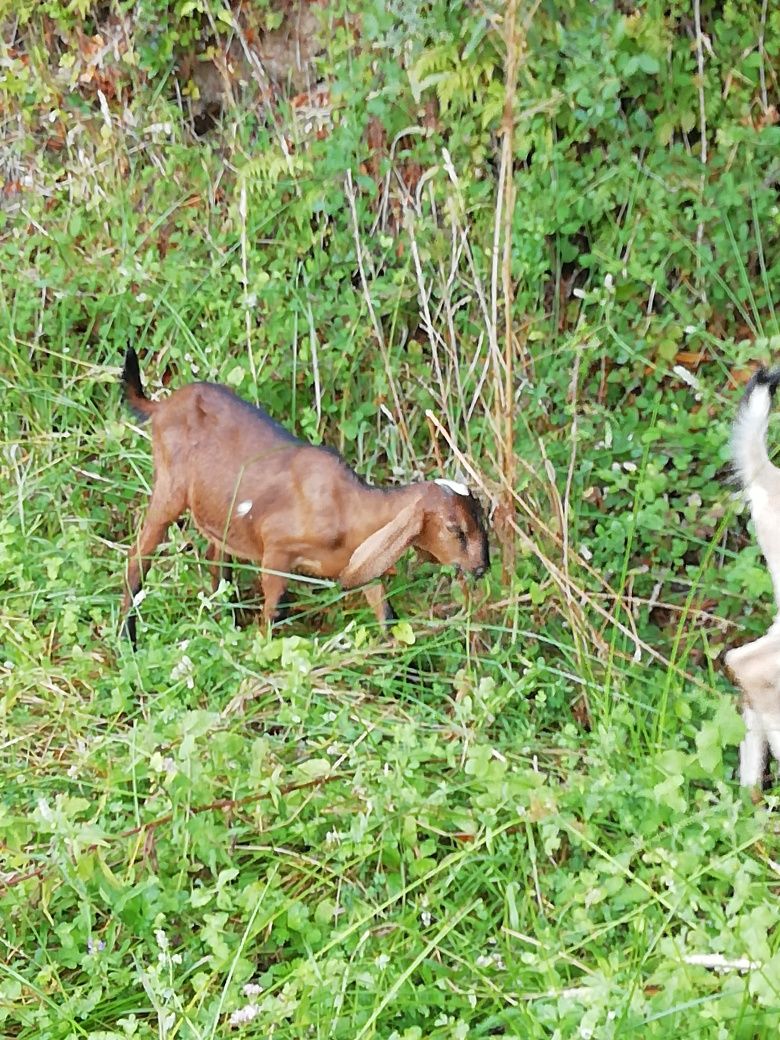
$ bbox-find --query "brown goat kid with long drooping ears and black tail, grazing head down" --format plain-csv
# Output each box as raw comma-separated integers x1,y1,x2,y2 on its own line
122,347,490,645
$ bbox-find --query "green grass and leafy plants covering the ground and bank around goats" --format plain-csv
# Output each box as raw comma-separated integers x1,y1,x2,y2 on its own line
0,0,780,1040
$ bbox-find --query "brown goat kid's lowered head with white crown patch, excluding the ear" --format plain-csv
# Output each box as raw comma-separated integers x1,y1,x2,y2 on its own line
414,479,490,577
